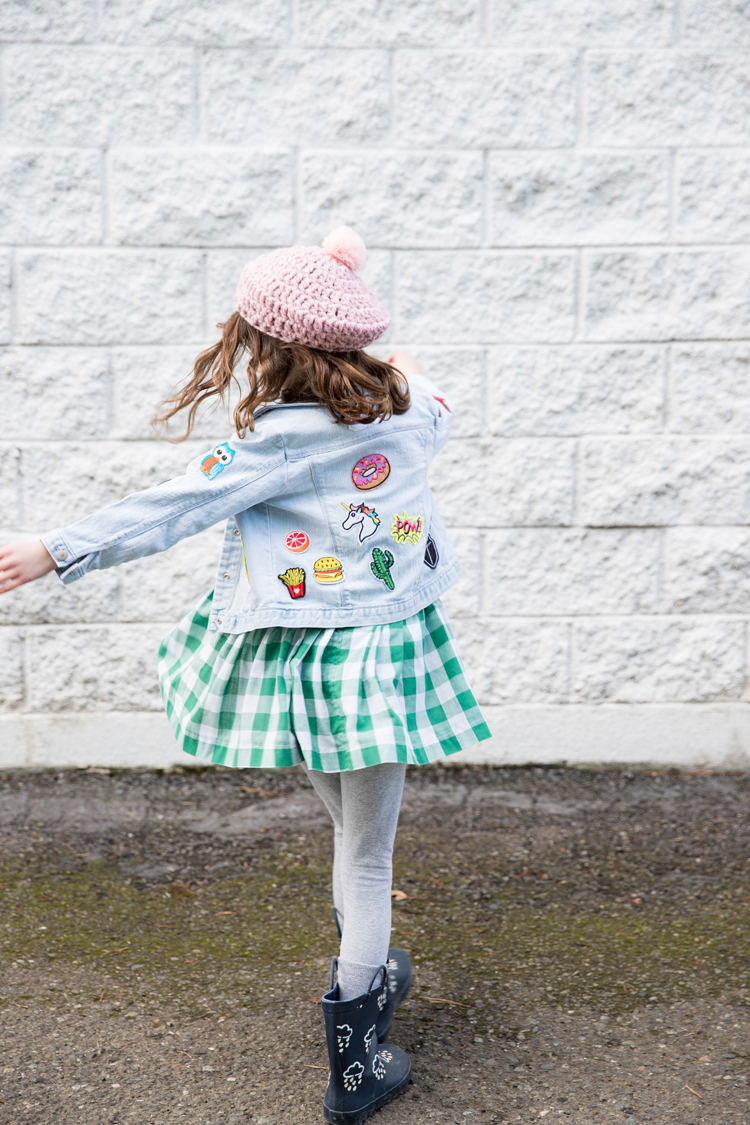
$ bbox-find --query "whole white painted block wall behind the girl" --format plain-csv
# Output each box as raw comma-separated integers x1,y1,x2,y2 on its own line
0,0,750,766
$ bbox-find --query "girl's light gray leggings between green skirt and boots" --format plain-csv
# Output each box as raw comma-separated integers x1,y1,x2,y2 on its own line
306,763,406,1000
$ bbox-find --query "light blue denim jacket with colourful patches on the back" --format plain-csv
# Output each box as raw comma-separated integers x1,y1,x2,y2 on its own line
43,378,461,633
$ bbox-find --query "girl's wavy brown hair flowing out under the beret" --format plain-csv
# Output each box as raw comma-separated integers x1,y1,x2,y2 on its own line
153,313,409,441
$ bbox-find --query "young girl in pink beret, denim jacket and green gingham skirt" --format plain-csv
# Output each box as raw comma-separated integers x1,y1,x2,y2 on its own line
0,227,490,1125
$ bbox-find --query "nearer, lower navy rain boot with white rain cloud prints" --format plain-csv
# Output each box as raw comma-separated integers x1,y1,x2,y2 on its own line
320,957,412,1125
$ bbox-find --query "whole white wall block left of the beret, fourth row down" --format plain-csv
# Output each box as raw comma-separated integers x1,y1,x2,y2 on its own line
18,250,204,344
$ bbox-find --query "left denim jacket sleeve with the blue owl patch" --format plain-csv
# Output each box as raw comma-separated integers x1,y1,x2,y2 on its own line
42,426,287,583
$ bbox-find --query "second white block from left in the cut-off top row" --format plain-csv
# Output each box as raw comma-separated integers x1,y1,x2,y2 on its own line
101,0,291,47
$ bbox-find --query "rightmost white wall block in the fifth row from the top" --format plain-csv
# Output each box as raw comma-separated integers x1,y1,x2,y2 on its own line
670,344,750,433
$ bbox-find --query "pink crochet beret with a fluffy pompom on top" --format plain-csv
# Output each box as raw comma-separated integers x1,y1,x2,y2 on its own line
235,226,390,351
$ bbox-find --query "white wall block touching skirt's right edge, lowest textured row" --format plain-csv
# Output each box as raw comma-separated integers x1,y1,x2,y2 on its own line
454,619,570,705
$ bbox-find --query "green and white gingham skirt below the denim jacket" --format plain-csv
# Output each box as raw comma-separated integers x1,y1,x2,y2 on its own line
159,592,490,773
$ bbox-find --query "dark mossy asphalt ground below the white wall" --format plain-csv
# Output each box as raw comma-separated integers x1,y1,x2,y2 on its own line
0,767,750,1125
